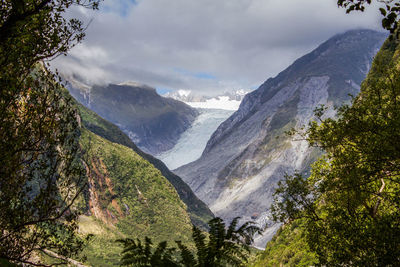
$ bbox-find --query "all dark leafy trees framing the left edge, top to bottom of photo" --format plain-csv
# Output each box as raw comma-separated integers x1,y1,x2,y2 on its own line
0,0,98,266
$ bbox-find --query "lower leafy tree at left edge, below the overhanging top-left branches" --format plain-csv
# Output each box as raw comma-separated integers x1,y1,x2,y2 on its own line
0,68,91,264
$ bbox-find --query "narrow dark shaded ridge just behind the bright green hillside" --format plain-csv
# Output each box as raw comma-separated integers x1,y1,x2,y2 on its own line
78,104,214,227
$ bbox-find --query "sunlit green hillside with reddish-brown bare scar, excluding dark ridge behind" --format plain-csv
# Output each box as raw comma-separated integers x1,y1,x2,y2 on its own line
80,129,192,266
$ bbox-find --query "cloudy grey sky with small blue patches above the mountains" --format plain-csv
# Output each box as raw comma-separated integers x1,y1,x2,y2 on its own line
51,0,381,95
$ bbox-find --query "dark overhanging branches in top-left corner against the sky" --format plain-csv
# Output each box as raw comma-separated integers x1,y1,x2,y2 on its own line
0,0,99,98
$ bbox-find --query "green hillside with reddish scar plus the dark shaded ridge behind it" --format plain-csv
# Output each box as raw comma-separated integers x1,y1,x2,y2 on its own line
53,88,213,266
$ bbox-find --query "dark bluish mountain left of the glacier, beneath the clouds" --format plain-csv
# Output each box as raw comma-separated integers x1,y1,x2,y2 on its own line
67,83,198,155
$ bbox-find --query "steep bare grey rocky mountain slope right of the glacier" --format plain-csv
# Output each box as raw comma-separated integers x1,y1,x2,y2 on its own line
175,30,386,245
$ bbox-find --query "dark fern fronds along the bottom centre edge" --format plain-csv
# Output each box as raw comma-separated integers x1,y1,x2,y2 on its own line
118,217,261,267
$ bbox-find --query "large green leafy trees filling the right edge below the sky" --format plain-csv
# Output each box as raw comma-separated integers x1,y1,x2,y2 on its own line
272,39,400,266
